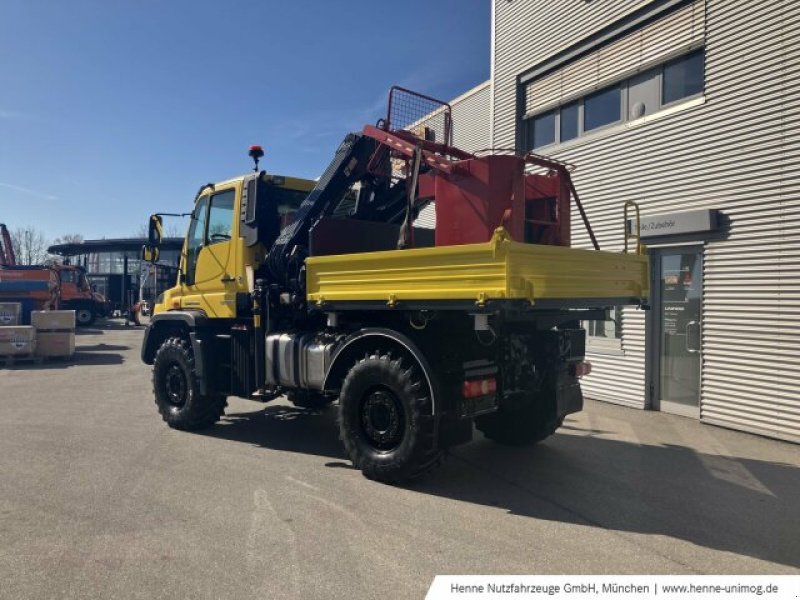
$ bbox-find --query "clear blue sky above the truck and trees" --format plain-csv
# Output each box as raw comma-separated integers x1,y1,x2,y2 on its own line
0,0,490,239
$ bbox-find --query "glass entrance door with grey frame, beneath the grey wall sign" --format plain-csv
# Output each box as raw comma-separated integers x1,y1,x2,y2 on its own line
652,247,703,417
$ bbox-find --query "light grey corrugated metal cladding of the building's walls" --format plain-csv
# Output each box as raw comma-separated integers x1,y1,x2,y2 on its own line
493,0,800,441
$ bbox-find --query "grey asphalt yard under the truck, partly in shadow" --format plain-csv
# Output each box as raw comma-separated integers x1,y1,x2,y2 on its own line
0,322,800,599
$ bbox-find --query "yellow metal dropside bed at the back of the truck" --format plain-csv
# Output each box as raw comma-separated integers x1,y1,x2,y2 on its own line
306,228,649,306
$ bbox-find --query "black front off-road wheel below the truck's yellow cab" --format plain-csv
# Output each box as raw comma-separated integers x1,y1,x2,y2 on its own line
153,337,228,431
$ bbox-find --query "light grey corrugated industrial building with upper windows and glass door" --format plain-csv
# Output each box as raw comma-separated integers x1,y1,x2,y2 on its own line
438,0,800,442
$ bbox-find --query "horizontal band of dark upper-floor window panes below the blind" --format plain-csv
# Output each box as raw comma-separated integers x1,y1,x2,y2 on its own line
524,49,705,150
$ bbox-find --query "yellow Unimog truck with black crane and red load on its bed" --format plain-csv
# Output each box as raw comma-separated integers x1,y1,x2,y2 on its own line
142,88,649,482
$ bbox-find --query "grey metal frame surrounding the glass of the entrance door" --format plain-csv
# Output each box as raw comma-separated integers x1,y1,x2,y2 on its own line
645,242,705,419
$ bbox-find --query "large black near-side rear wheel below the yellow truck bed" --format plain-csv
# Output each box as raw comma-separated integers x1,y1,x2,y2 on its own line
339,351,444,483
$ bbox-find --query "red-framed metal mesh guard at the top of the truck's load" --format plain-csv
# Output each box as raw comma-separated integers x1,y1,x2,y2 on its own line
386,86,451,145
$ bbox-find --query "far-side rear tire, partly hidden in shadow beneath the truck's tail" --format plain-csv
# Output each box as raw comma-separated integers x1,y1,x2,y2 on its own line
475,405,564,446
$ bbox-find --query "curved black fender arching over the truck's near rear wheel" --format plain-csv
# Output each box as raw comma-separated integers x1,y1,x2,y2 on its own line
322,328,439,415
